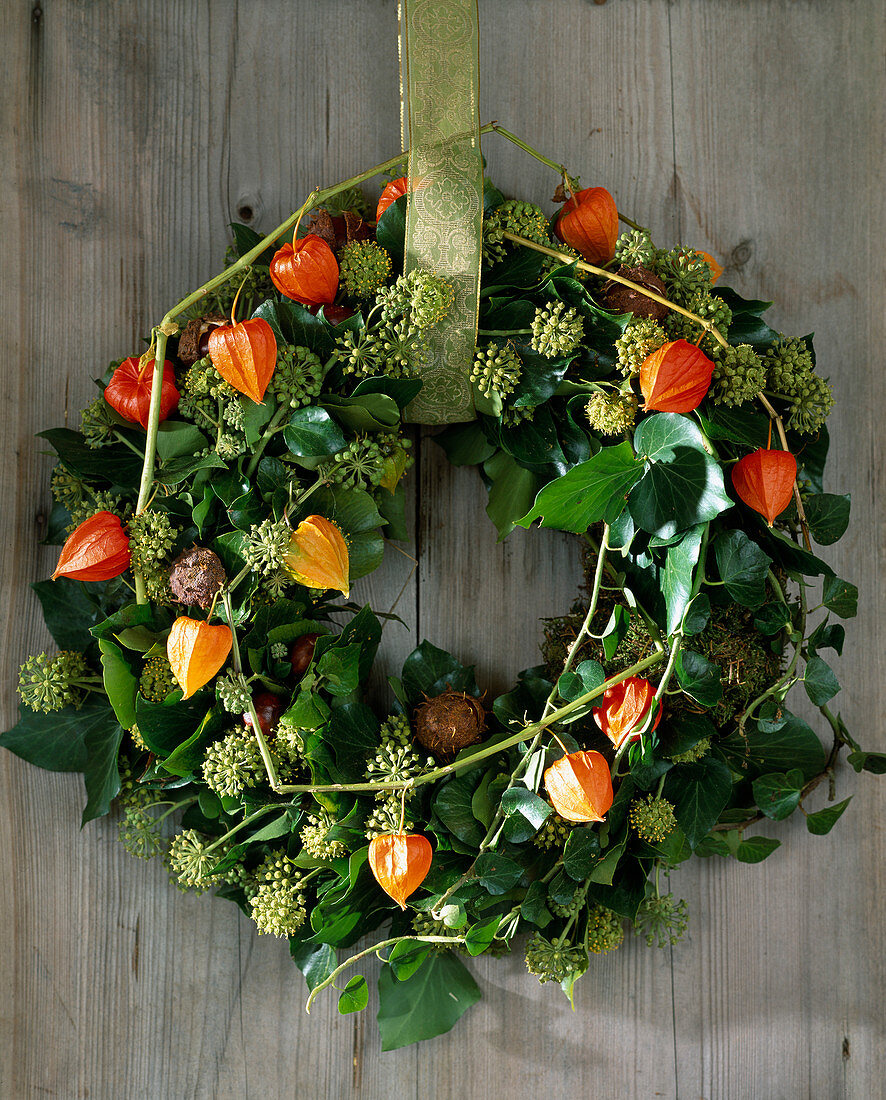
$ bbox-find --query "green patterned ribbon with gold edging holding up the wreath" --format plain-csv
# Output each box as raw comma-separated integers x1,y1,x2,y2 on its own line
404,0,483,424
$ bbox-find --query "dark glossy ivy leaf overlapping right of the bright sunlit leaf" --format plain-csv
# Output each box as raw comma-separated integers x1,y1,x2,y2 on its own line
625,446,732,538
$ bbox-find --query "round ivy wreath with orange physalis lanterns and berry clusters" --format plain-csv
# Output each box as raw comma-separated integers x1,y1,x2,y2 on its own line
6,124,886,1049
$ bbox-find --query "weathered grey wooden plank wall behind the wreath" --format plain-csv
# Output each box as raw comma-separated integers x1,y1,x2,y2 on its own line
0,0,886,1100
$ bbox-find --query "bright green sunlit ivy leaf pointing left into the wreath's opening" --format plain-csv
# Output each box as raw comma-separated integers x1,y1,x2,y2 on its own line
517,441,643,535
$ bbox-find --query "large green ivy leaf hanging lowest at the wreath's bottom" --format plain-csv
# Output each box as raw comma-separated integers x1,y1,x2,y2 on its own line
379,950,481,1051
